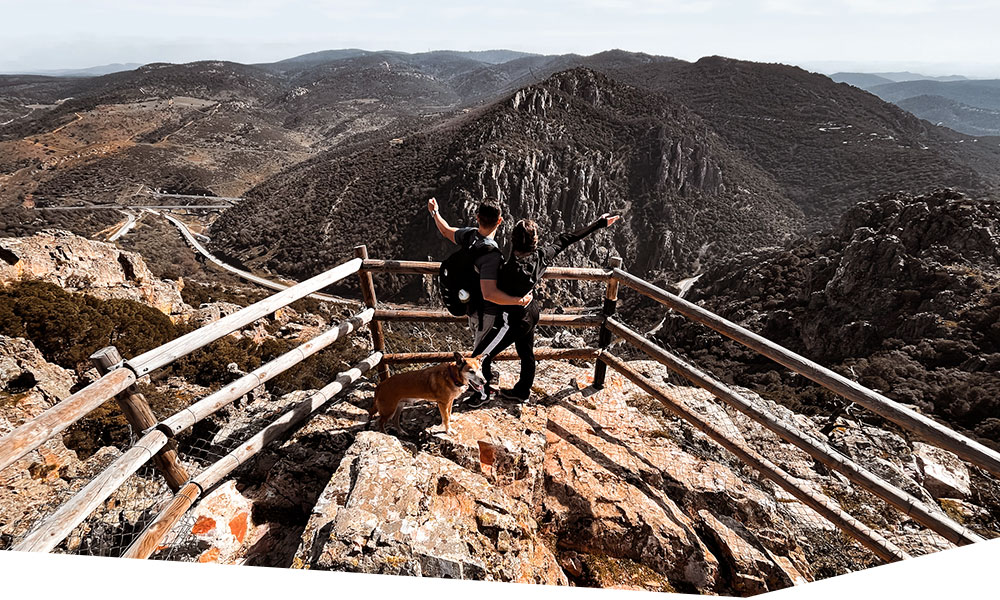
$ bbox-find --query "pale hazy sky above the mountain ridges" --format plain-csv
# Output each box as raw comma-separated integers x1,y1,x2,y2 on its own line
0,0,1000,78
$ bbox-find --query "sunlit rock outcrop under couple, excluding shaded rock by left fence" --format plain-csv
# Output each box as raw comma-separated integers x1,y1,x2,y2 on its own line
276,362,920,594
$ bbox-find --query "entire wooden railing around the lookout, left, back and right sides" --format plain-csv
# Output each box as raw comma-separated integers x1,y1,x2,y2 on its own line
0,246,1000,561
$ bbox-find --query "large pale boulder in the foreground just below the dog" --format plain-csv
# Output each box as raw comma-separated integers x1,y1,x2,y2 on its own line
299,432,566,583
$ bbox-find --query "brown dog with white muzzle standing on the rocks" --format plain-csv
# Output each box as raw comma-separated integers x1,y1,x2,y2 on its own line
368,352,486,435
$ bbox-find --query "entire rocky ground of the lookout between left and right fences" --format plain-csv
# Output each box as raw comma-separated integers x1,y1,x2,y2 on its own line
145,361,972,595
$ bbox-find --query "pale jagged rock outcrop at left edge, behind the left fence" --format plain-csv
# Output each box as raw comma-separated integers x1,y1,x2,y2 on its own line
0,230,191,319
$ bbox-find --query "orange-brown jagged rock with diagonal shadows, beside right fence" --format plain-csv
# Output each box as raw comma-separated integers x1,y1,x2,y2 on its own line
544,372,829,593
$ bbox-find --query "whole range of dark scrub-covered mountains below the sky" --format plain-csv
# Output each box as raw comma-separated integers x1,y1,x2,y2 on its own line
0,49,1000,288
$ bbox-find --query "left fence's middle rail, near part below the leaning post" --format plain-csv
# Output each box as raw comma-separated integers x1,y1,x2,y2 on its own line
13,430,168,552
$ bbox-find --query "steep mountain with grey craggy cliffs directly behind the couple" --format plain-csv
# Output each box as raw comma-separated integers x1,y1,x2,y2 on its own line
212,69,801,291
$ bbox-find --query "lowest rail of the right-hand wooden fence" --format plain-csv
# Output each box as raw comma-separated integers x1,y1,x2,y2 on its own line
598,350,910,561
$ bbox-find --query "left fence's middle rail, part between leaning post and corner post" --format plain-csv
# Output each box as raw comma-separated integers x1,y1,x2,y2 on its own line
159,308,375,436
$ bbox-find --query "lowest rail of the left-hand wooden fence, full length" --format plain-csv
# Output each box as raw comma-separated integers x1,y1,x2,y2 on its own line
122,352,382,558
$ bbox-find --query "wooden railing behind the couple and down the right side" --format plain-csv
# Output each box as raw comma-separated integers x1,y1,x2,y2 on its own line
359,251,1000,560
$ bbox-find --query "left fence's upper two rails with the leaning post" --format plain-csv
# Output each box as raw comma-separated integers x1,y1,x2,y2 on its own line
0,259,372,551
